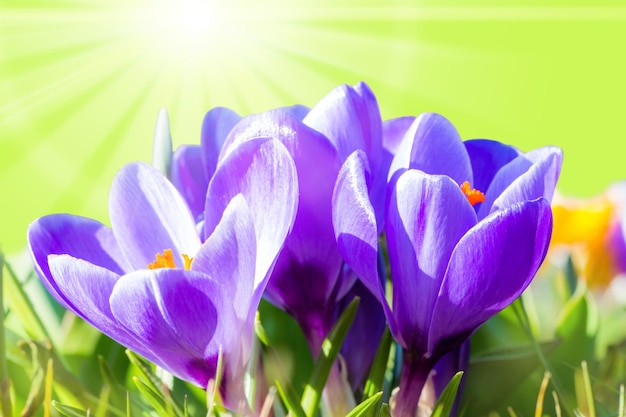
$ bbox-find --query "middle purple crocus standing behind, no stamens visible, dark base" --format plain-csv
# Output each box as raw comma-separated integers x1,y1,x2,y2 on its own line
217,84,385,415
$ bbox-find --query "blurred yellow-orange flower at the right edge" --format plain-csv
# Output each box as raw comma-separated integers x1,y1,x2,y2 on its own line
549,182,626,288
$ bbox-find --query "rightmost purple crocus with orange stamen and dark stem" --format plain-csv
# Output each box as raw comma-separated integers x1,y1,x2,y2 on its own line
333,114,562,416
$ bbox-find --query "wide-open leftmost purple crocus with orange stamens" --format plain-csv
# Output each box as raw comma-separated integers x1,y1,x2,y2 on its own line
28,139,297,410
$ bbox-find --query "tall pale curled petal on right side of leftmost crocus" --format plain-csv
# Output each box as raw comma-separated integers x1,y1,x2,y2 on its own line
205,139,298,287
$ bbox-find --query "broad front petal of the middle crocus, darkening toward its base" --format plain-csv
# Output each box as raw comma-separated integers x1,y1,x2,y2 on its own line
217,110,342,355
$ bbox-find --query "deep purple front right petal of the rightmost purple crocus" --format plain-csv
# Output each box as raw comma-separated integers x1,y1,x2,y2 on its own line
429,199,552,354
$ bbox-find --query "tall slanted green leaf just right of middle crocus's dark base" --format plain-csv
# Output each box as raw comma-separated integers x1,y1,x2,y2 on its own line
300,297,359,417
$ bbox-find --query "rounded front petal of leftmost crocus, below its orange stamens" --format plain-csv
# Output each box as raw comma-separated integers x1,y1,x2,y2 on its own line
110,268,235,388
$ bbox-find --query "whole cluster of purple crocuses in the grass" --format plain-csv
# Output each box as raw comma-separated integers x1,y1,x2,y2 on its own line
28,83,562,417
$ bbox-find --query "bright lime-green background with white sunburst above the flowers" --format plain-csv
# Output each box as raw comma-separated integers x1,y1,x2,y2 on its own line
0,0,626,253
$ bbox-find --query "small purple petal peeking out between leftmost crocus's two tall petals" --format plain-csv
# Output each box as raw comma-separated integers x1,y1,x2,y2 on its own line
170,145,209,219
